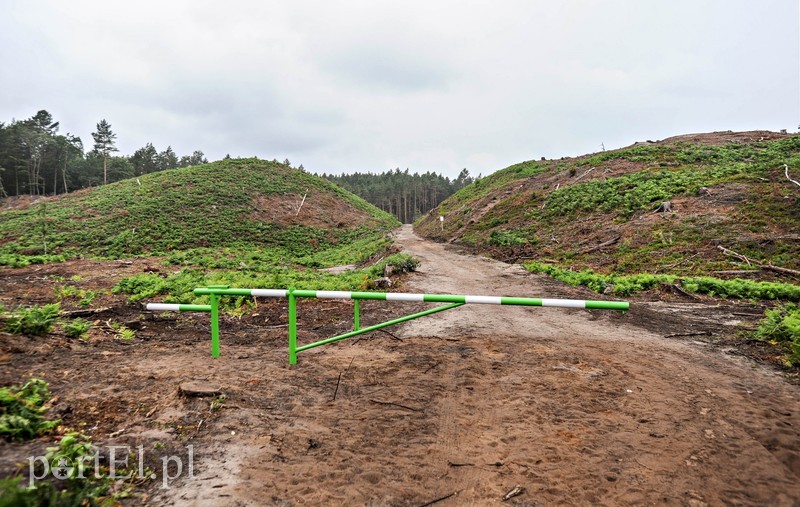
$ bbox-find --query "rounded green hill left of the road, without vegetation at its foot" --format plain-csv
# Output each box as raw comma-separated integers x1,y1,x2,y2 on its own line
0,159,397,268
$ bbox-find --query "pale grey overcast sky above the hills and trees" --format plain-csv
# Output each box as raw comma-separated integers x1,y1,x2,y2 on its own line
0,0,800,177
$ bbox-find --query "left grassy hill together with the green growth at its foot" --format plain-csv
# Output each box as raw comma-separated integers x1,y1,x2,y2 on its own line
0,159,398,302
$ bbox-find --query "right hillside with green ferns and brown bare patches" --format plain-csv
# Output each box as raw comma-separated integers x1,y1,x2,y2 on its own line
415,133,800,330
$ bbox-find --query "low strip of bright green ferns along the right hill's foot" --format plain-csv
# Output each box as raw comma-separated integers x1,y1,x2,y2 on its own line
524,262,800,301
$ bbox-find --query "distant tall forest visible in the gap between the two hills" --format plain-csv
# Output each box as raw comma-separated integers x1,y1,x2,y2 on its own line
322,168,480,224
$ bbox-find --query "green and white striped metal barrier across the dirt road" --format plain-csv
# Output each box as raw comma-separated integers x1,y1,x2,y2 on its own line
147,285,630,364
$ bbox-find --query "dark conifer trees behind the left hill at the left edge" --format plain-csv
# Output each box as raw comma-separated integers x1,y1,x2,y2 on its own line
0,110,208,197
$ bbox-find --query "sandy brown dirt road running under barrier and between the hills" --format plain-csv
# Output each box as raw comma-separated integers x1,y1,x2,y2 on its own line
153,227,800,506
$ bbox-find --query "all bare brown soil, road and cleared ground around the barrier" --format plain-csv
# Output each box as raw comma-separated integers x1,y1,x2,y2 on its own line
0,226,800,506
